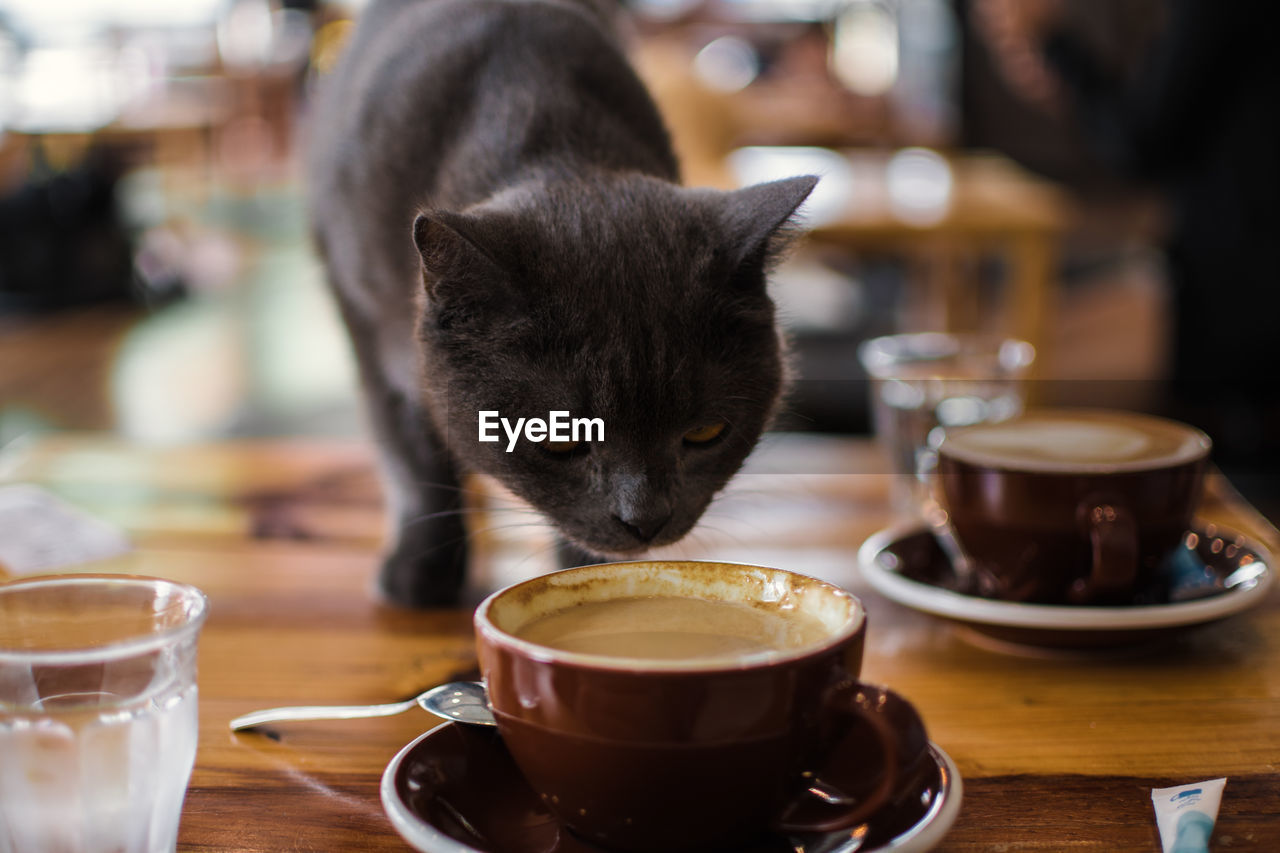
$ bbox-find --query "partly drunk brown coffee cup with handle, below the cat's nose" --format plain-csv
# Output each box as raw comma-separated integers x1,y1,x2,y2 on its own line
475,562,932,853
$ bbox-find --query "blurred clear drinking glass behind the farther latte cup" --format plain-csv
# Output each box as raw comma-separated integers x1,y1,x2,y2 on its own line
858,332,1036,514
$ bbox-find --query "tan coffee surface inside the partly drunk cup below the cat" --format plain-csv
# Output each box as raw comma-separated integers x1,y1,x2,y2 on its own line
515,596,828,661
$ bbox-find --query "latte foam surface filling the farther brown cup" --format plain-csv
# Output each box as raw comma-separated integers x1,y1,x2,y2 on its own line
940,410,1210,473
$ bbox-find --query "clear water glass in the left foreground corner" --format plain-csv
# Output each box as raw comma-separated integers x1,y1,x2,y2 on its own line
0,575,207,853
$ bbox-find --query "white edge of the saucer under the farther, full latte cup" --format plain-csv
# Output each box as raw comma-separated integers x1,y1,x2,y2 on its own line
858,523,1276,631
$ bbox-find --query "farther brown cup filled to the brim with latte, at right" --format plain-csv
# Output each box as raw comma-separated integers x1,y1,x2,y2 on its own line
937,409,1211,605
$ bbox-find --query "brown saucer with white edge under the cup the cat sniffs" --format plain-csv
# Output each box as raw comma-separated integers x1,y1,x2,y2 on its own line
381,722,961,853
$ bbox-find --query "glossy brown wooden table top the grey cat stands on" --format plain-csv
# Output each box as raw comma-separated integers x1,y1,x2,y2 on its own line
0,435,1280,853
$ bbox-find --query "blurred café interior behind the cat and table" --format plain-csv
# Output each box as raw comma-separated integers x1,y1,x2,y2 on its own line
0,0,1280,519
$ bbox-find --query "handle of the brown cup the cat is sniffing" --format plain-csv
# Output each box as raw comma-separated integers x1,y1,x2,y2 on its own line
774,681,934,833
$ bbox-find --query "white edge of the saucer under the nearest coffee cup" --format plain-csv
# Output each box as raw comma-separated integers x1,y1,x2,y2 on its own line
380,722,964,853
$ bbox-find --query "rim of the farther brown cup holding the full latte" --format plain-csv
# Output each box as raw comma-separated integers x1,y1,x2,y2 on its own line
938,407,1213,476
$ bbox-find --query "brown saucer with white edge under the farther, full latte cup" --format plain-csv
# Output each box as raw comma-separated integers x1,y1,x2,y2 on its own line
858,520,1275,649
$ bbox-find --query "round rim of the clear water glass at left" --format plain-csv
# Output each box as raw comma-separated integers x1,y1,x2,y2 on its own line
0,573,209,666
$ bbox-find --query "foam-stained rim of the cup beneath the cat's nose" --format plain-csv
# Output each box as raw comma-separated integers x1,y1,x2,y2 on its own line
472,560,867,675
